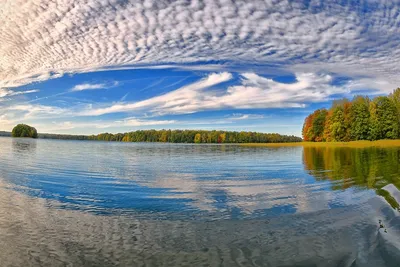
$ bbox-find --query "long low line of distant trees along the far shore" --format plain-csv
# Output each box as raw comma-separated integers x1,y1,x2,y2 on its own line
39,130,302,144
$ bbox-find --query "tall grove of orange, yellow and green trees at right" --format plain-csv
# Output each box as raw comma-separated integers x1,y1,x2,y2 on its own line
302,88,400,142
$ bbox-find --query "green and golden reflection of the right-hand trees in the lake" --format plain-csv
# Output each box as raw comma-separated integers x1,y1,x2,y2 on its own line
303,147,400,209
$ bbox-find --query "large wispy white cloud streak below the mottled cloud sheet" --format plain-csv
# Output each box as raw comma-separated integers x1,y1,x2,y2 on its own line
81,72,351,116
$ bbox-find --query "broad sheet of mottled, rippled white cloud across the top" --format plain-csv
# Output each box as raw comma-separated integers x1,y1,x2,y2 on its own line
0,0,400,91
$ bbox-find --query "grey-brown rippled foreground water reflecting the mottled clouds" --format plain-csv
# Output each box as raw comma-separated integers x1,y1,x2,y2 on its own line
0,180,400,267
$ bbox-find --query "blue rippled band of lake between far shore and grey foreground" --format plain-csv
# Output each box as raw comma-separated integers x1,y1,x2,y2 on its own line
0,139,390,218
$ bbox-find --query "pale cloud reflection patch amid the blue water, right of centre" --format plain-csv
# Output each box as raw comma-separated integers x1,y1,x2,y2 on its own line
147,174,340,214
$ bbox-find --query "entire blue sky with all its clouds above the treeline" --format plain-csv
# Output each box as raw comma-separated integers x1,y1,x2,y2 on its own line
0,0,400,136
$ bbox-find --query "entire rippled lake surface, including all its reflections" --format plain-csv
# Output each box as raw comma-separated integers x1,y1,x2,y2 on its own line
0,138,400,267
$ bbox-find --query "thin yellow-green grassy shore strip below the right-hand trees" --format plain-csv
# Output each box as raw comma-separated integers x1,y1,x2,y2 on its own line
240,139,400,148
